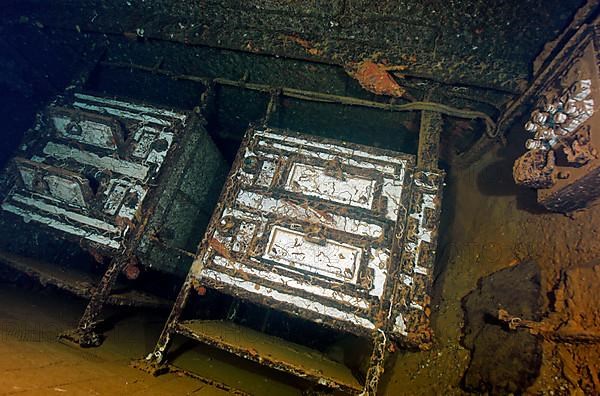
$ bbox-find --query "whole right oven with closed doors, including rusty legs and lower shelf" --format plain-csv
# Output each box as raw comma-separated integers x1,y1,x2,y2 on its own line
145,127,444,394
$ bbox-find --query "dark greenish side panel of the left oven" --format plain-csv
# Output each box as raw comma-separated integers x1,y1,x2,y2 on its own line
137,119,229,277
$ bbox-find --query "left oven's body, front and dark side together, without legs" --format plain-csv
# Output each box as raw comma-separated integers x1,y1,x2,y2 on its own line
2,93,227,275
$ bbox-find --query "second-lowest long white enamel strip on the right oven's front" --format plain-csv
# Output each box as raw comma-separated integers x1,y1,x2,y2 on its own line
213,256,369,309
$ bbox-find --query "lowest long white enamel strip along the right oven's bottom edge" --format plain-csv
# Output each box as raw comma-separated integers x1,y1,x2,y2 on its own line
201,268,375,330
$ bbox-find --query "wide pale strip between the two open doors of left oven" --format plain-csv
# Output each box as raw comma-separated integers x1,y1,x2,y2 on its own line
44,142,148,180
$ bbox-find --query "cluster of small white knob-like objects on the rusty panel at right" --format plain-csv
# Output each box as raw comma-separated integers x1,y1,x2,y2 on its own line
525,80,594,150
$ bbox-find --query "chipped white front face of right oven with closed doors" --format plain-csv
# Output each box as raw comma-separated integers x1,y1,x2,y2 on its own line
192,128,440,342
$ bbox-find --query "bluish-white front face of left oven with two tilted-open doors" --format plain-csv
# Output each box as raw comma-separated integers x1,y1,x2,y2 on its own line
2,93,187,250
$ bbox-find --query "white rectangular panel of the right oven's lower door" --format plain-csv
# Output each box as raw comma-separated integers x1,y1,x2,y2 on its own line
263,226,362,283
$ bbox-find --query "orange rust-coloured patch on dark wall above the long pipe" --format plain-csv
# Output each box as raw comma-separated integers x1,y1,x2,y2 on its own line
346,60,406,97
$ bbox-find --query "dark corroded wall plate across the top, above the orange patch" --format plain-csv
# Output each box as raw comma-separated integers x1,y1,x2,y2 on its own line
3,0,582,92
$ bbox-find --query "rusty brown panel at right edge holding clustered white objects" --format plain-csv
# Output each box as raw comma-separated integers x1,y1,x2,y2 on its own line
513,26,600,212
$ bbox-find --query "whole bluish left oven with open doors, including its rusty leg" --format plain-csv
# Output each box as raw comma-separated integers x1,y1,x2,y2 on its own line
0,92,228,345
